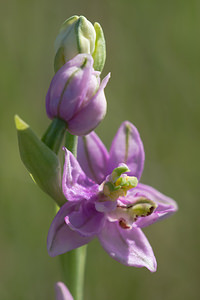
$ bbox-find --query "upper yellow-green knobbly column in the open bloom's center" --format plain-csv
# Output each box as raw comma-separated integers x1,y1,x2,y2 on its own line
103,164,138,201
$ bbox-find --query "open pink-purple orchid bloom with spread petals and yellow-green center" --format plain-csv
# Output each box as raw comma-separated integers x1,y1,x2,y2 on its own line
47,121,177,272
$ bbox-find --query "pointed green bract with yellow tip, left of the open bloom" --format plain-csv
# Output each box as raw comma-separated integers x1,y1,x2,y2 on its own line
15,116,66,206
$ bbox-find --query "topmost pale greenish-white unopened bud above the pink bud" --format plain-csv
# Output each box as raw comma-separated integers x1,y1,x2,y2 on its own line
54,16,106,71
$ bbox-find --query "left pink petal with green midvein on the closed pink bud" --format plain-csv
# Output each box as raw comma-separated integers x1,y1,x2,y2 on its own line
46,54,93,122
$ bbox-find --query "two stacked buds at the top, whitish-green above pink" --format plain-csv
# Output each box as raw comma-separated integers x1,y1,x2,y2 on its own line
46,16,110,135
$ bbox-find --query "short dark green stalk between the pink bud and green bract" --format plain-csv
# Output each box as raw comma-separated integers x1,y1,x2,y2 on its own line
41,118,67,154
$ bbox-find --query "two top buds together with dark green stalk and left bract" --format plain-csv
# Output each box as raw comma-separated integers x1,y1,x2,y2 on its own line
15,16,110,206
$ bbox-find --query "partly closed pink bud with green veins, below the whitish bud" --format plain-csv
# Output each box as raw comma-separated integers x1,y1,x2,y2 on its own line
46,54,110,135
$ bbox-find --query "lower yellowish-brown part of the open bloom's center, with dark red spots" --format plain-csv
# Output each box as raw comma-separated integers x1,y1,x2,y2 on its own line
109,197,157,229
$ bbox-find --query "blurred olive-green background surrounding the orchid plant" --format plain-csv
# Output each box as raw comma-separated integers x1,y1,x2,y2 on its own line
0,0,200,300
